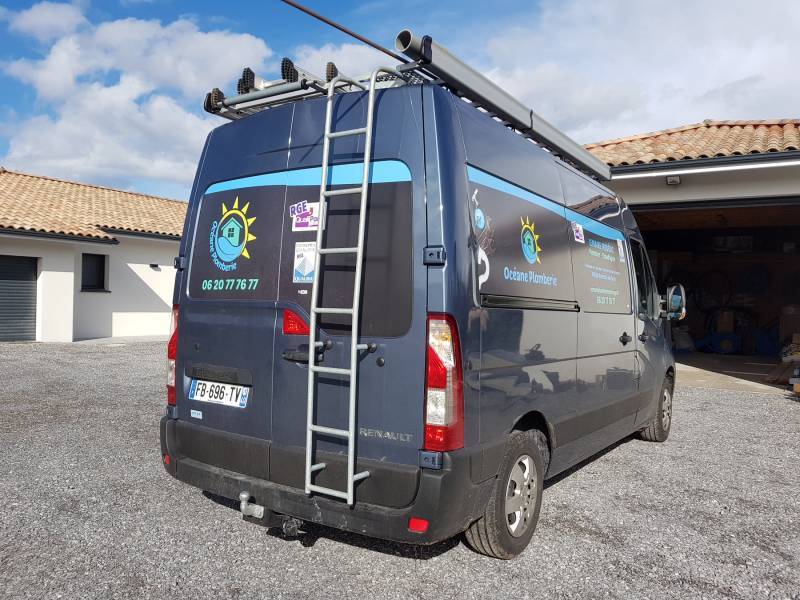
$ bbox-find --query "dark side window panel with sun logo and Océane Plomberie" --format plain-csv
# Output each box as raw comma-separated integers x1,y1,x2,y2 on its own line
467,166,575,302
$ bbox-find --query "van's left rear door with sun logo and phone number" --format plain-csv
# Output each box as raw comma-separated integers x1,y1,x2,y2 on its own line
178,102,293,446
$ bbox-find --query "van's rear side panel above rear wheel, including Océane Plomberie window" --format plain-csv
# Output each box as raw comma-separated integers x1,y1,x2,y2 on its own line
467,166,578,452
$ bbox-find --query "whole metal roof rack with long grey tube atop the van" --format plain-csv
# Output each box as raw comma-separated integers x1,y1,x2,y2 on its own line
204,29,611,180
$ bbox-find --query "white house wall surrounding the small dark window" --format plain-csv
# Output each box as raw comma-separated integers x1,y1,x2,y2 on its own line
74,236,179,340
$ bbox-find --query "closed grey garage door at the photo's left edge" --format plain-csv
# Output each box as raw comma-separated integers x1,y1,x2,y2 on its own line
0,255,36,342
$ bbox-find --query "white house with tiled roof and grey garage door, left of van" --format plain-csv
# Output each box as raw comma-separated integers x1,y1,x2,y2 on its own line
0,167,186,342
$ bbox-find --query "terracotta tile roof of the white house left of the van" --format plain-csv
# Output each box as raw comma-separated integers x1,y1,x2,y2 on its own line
0,167,187,241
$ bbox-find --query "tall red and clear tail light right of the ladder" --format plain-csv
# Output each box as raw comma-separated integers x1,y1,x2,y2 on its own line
425,313,464,452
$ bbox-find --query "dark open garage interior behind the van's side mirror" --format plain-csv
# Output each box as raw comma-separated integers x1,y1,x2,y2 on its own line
632,199,800,383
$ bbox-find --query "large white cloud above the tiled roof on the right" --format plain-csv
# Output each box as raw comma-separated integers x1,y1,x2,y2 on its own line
482,0,800,142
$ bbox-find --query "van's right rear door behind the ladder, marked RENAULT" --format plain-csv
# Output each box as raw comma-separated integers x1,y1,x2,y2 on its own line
271,86,426,506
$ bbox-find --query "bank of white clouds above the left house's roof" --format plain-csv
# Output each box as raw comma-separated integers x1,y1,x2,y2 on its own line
0,11,272,195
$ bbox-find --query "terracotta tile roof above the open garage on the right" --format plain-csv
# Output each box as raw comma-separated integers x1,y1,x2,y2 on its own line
586,119,800,167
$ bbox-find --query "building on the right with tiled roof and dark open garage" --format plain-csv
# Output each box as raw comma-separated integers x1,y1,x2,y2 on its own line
587,119,800,354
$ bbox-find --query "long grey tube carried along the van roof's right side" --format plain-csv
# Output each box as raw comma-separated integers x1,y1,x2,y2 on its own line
395,29,611,180
